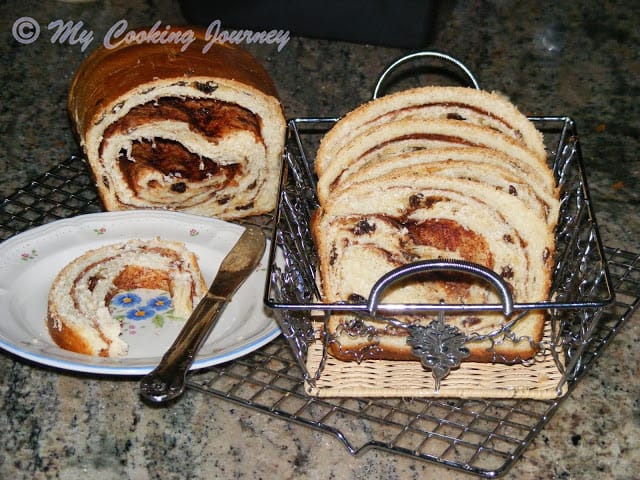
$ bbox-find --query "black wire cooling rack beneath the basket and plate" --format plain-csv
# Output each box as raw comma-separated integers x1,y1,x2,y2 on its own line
0,157,640,478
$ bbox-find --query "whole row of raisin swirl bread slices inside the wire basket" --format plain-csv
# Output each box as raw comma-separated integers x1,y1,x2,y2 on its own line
312,87,559,363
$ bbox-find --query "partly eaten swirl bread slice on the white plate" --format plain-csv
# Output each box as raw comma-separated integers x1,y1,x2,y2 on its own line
47,238,206,357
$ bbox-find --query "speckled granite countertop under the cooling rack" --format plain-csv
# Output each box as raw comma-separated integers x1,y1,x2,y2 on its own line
0,0,640,480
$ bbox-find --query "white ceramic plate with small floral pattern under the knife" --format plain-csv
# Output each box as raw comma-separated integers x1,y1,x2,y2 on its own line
0,210,280,375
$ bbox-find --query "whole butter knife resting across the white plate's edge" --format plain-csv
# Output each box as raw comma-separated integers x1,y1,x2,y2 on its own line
140,226,266,403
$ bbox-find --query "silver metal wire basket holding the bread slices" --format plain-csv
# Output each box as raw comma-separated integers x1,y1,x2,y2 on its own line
265,51,614,397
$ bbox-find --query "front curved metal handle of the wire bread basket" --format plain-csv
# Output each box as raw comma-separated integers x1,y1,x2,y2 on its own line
367,259,513,317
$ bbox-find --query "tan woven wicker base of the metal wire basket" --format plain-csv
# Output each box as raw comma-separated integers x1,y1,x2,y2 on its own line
305,328,566,400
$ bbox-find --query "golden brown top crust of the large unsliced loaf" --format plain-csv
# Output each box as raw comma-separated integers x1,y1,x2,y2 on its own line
68,27,278,138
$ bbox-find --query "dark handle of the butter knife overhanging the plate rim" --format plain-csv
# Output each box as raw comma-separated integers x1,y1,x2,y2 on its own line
140,292,227,403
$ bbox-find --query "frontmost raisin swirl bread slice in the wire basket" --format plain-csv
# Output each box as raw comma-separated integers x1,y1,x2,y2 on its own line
313,174,554,362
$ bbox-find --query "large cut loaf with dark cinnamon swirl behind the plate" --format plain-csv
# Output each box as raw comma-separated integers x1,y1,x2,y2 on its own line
68,29,286,219
